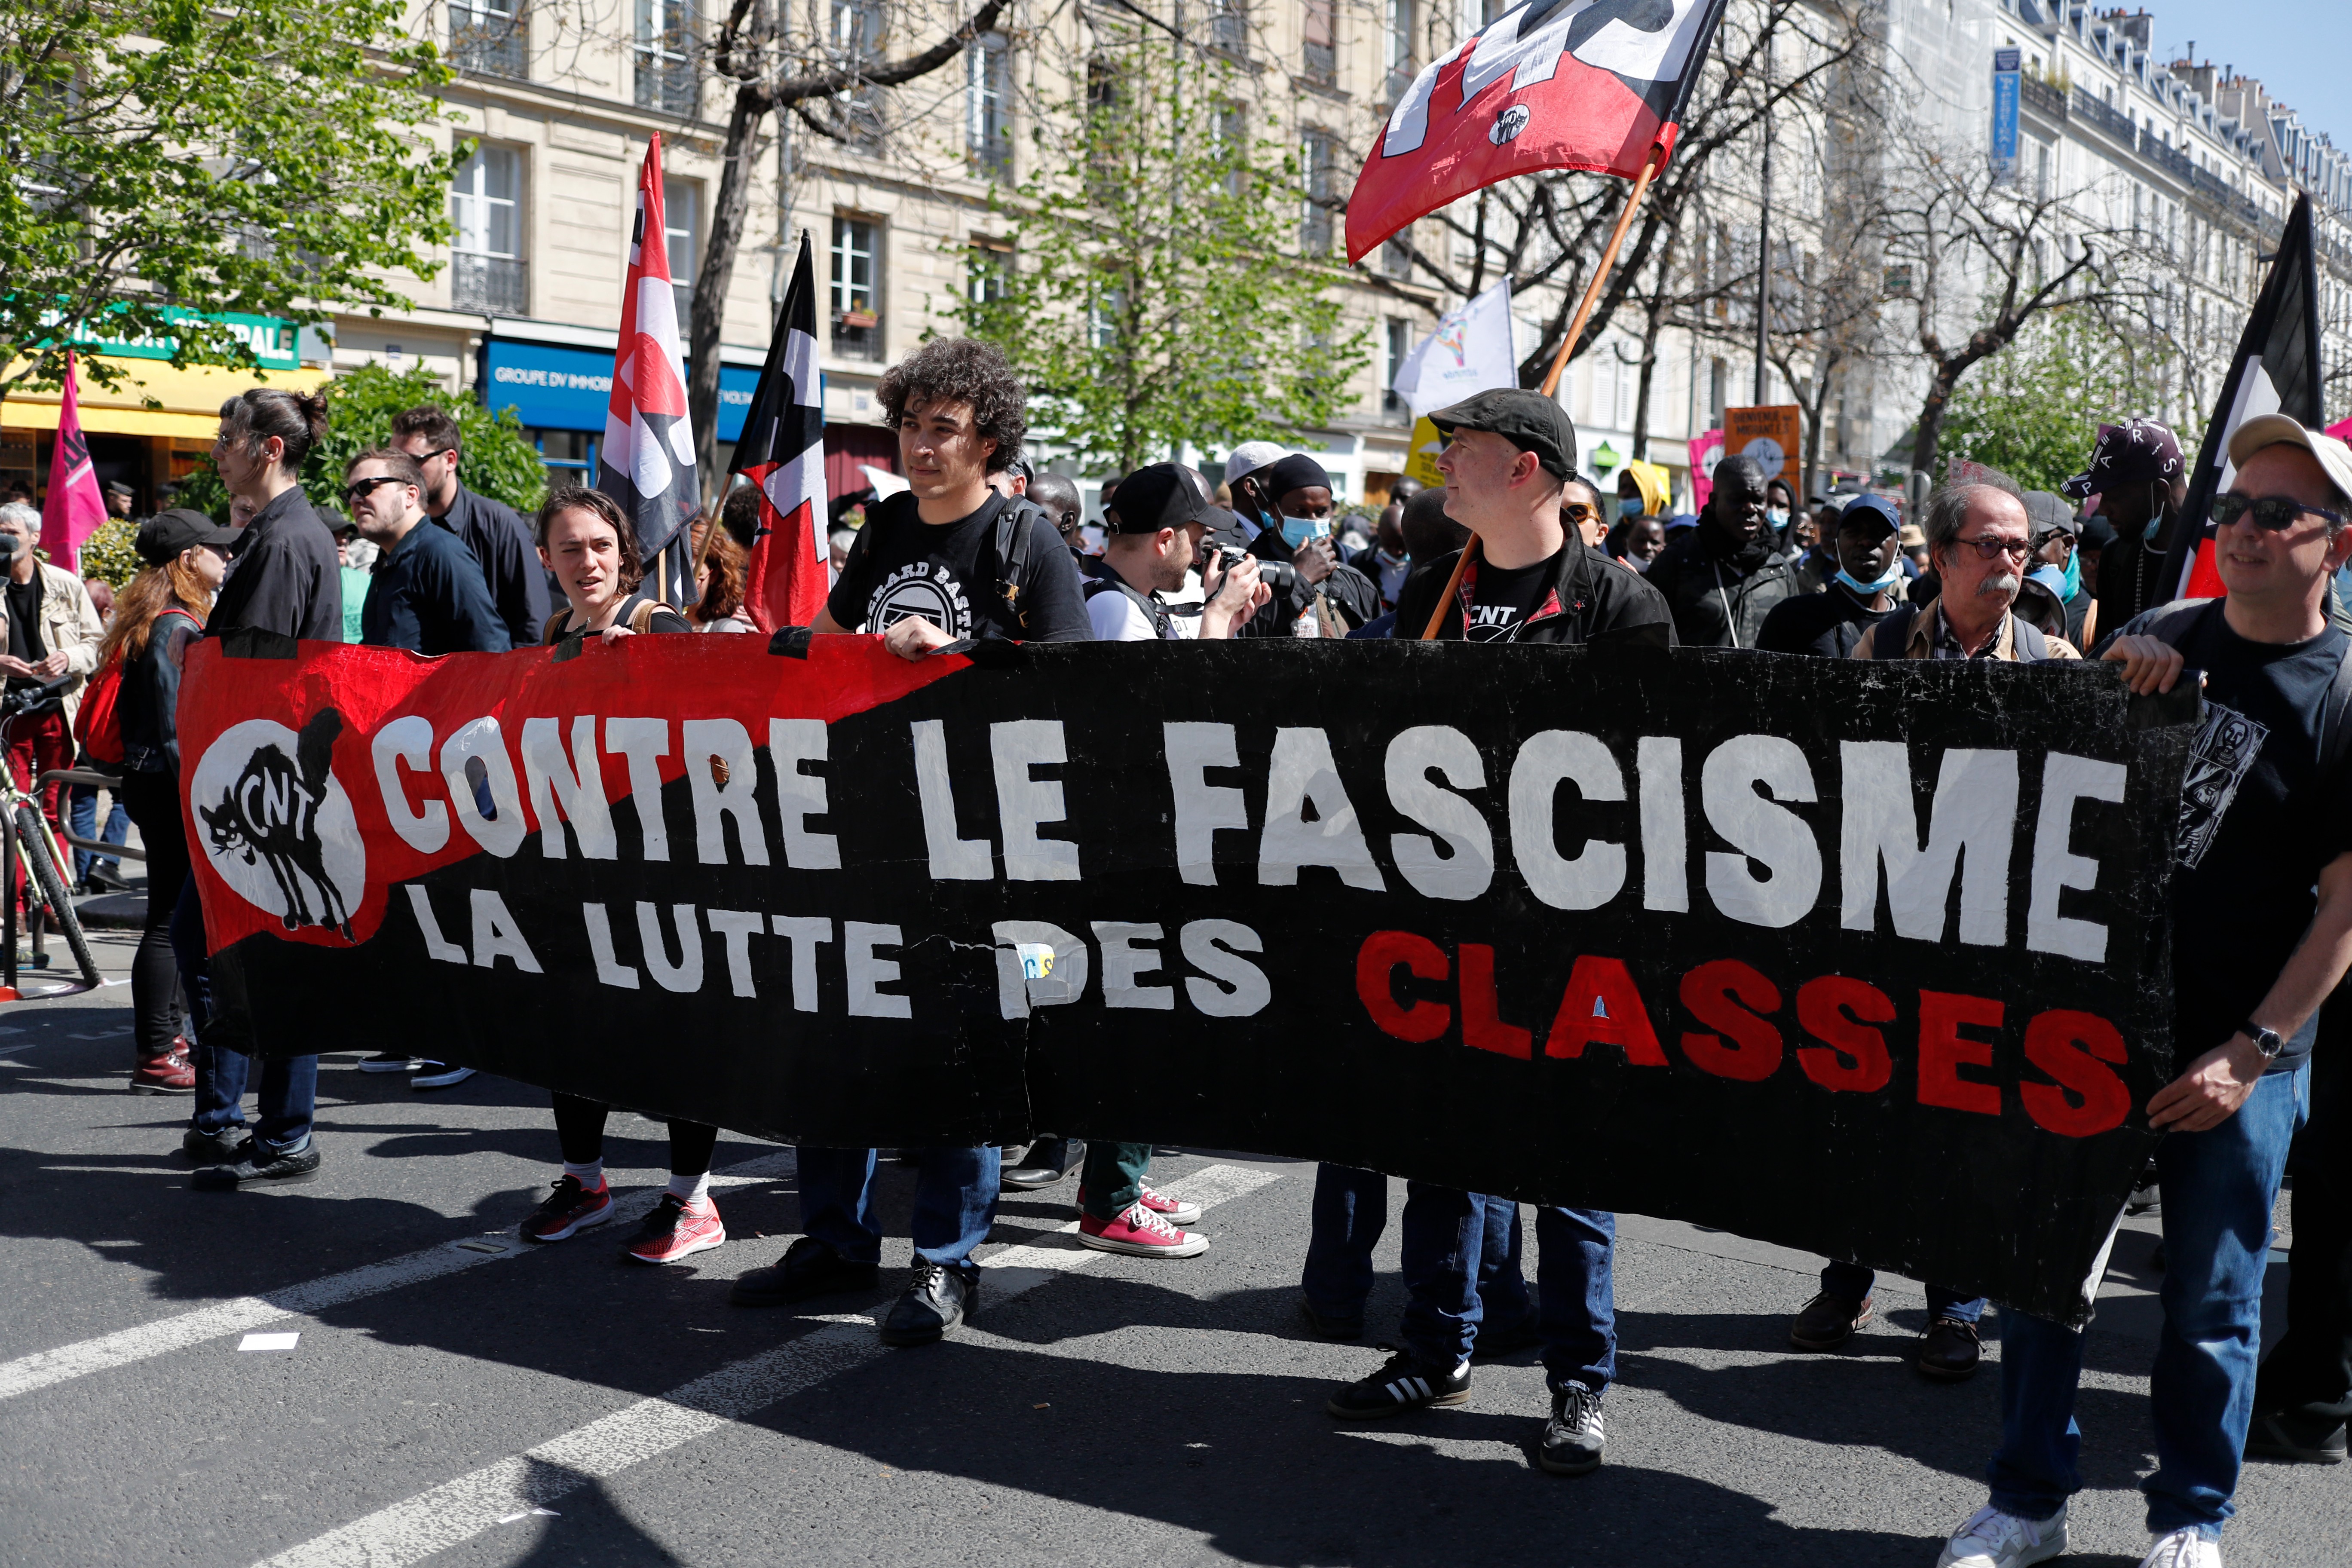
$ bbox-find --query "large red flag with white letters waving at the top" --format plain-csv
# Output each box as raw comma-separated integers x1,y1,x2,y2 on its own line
1348,0,1724,261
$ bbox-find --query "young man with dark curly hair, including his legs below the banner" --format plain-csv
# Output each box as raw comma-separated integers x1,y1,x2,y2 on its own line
734,339,1089,1344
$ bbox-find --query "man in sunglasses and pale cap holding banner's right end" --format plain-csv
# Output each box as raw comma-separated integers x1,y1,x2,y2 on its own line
1940,414,2352,1568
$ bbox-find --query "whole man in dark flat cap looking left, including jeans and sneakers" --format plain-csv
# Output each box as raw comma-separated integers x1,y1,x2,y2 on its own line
1308,388,1675,1476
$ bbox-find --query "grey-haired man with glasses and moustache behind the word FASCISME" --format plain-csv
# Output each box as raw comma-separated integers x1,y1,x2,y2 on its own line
1853,470,2082,663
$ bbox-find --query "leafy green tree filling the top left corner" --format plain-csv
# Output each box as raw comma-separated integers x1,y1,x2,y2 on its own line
0,0,449,411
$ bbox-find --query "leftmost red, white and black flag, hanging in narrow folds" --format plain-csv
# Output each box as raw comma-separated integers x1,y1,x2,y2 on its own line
595,132,703,604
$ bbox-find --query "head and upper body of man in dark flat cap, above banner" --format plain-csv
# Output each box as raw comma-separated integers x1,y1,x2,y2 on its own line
1397,388,1675,649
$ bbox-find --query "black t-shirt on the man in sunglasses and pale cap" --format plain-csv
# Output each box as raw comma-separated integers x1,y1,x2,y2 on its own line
2141,604,2352,1072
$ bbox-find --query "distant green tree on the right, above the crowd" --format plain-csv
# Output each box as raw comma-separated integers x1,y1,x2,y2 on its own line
1940,310,2197,489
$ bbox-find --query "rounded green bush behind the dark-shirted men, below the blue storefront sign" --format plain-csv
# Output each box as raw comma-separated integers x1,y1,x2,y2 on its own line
174,364,548,522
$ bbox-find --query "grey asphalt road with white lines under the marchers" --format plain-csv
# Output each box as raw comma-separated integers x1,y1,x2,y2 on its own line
0,938,2352,1568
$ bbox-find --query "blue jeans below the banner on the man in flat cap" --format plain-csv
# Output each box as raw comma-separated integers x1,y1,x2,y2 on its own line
1402,1182,1616,1392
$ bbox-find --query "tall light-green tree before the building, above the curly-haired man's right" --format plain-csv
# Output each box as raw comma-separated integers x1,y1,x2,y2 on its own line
950,24,1366,472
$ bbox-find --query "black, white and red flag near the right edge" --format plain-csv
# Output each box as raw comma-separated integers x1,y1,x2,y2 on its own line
2159,195,2326,602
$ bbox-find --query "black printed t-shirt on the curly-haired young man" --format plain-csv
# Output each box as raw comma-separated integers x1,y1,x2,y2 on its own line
826,491,1093,642
